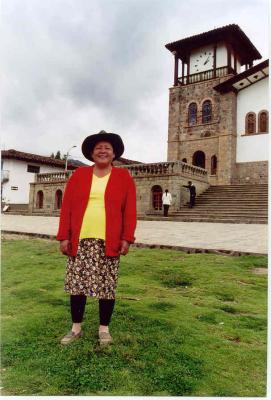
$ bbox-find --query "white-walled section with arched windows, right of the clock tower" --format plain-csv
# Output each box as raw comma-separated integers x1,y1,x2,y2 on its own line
216,60,269,163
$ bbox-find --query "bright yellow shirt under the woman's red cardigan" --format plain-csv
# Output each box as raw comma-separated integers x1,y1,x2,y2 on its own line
80,173,110,240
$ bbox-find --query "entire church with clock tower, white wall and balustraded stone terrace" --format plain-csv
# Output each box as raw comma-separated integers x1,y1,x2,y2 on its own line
29,25,269,216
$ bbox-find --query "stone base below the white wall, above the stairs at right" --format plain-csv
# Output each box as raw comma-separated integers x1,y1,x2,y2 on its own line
233,161,268,184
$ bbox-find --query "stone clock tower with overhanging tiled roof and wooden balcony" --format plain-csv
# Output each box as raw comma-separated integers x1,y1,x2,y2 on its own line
166,24,261,185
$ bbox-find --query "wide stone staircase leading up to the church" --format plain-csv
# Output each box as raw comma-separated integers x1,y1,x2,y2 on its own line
148,184,268,224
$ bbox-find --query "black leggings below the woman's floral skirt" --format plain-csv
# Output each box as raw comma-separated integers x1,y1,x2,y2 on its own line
70,294,115,326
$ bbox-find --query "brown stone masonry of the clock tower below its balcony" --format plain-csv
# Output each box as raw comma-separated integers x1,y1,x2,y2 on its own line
168,75,239,185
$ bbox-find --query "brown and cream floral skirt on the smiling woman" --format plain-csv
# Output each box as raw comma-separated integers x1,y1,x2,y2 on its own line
65,239,119,299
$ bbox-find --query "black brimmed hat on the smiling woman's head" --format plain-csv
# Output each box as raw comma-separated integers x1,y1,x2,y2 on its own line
82,131,124,161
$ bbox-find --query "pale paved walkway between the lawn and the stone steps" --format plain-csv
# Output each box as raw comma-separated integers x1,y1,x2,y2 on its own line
2,214,268,254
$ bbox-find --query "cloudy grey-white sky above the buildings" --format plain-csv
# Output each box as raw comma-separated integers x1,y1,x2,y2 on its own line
2,0,269,162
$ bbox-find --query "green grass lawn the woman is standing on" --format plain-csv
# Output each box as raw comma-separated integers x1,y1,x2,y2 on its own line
2,237,267,397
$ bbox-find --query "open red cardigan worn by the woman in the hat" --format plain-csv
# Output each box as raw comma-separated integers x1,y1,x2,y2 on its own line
56,166,136,256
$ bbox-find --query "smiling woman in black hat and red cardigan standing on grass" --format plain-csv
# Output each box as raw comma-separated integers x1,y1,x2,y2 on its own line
57,131,136,344
